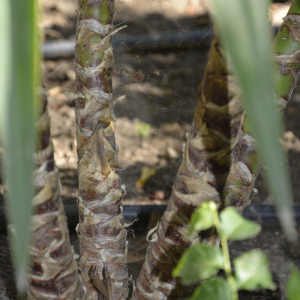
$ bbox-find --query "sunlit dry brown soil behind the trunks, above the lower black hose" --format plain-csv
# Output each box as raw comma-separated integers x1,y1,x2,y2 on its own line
42,0,300,204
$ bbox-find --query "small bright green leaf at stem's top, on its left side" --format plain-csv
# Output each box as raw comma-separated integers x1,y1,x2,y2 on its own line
188,202,214,237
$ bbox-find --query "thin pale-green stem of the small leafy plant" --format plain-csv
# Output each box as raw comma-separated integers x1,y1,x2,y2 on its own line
209,202,238,300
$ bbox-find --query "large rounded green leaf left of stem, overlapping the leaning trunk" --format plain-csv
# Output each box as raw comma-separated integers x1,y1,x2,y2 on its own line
172,244,224,284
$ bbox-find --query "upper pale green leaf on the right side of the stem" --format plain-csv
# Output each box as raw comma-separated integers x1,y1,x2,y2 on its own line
220,207,261,241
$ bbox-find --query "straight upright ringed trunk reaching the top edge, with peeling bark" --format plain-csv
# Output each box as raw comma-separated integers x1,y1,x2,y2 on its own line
68,0,128,300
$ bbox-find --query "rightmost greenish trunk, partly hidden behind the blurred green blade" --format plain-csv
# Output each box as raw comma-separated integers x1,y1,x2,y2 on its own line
222,1,300,211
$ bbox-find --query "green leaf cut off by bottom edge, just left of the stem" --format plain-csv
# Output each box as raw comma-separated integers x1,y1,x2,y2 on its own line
190,276,232,300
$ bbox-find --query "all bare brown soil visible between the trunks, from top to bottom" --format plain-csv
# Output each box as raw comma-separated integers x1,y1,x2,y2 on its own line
0,0,300,300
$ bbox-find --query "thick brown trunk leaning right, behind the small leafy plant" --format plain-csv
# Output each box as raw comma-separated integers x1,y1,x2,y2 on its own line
136,39,243,300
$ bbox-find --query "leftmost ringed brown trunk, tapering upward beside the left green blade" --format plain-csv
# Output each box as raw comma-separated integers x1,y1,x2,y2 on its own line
28,92,85,300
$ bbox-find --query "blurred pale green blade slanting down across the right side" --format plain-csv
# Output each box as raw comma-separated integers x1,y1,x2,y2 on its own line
211,0,296,241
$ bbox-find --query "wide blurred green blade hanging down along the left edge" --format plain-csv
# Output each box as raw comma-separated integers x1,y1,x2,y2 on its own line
0,0,39,292
